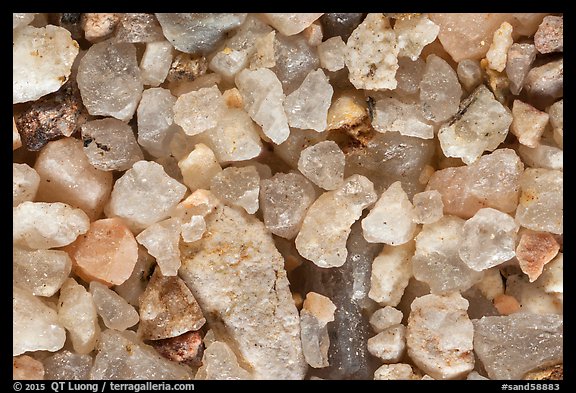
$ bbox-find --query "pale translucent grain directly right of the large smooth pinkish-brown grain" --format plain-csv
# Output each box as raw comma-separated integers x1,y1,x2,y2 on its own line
105,161,186,232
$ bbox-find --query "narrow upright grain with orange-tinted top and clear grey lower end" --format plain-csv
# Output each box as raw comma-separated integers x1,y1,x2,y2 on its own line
300,292,336,368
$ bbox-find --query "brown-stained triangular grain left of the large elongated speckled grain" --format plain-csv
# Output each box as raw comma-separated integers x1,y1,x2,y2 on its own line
139,269,206,340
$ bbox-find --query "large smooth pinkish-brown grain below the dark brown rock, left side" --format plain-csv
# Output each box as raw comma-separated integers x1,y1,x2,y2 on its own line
34,138,113,220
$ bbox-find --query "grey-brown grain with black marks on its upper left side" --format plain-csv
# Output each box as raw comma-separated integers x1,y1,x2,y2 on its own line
82,118,144,171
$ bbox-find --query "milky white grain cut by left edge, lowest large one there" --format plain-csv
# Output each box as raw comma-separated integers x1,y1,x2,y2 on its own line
12,286,66,356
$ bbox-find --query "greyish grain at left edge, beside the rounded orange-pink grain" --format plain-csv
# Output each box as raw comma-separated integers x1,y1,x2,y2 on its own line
12,248,72,297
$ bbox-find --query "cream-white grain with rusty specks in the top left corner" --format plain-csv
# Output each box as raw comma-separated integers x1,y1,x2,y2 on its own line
12,25,79,104
